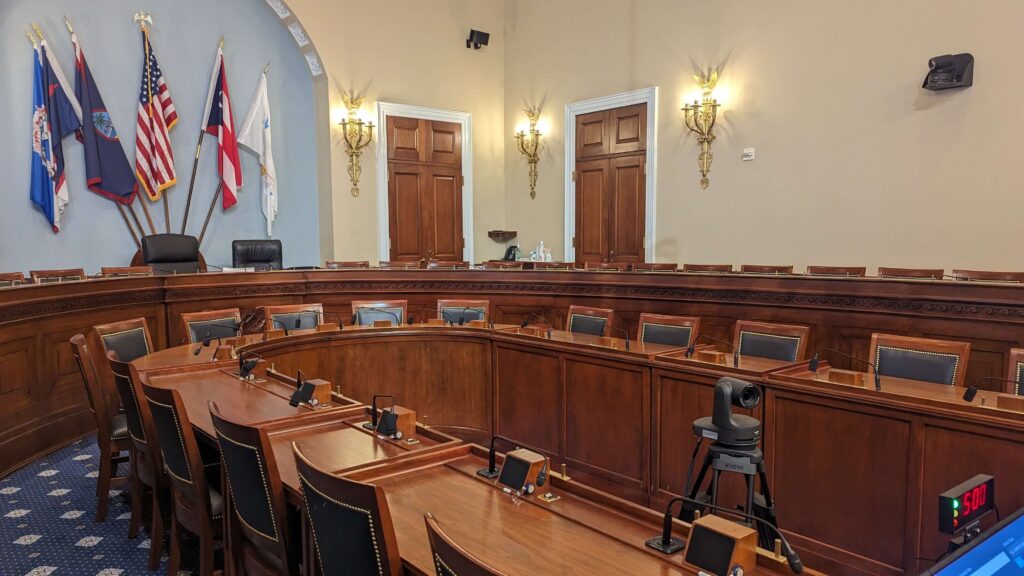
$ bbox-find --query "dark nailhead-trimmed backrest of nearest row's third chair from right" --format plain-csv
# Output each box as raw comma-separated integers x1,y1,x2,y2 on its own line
208,402,298,574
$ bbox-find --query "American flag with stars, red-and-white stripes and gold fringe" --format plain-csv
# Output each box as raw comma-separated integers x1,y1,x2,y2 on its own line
135,31,178,201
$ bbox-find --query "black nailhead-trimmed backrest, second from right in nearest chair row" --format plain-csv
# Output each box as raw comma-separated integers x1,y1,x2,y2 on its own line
292,443,401,576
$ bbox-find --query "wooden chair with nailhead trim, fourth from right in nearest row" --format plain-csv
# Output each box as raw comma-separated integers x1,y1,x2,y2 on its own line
142,383,224,576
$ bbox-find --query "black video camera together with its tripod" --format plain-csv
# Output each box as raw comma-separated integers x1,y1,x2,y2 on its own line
679,377,778,550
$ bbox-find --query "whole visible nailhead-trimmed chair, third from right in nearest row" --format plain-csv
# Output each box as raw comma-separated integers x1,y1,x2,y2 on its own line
208,402,299,576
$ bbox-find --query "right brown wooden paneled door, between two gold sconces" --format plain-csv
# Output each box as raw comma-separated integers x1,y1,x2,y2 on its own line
573,105,647,263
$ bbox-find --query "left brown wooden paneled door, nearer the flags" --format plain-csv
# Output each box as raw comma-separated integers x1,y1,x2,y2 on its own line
387,117,464,261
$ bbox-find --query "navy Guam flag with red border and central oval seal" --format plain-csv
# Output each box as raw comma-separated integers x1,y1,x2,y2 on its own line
71,34,138,204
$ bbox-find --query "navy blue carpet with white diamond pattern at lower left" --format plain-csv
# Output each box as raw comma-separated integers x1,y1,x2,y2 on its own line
0,439,195,576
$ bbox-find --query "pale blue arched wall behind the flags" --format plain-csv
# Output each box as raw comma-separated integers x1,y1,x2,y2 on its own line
0,0,321,274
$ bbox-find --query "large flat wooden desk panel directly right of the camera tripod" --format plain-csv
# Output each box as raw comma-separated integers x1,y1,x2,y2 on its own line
765,392,911,568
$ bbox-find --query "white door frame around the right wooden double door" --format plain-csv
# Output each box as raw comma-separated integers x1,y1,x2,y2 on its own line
563,86,657,262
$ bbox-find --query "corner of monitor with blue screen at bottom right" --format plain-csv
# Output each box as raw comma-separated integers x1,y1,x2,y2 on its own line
924,508,1024,576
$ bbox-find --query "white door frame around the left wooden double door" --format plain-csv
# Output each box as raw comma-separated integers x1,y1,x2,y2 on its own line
377,101,474,263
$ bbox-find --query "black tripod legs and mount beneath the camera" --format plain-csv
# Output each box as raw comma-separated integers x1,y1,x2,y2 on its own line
679,442,778,550
